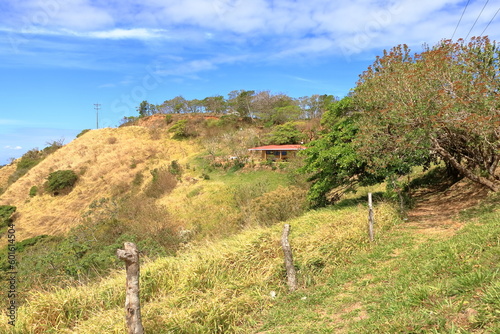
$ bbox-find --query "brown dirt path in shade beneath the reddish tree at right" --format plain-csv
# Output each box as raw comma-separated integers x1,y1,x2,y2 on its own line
406,181,487,237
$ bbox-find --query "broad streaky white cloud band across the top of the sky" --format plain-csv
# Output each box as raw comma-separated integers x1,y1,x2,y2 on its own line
0,0,500,63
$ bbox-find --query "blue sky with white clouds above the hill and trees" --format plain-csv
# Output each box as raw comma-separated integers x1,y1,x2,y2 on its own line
0,0,500,165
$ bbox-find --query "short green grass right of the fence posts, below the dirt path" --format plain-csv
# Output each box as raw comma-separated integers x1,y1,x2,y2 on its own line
252,195,500,334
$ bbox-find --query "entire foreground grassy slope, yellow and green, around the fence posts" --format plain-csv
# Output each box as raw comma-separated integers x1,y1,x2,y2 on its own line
0,187,500,333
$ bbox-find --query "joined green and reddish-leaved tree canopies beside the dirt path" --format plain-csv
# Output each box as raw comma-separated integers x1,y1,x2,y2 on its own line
305,38,500,205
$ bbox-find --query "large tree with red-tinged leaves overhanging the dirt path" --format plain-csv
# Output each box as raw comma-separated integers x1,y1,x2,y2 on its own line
354,37,500,191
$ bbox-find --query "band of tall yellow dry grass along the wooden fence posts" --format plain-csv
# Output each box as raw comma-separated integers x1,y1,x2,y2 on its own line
0,204,397,334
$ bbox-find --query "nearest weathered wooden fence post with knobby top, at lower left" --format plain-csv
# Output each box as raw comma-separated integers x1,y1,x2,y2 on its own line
116,242,144,334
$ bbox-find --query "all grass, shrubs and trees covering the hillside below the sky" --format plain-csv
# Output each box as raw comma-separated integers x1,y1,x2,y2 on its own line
0,38,500,334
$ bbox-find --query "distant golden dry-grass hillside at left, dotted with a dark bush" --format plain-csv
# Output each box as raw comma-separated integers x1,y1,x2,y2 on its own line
0,126,197,240
